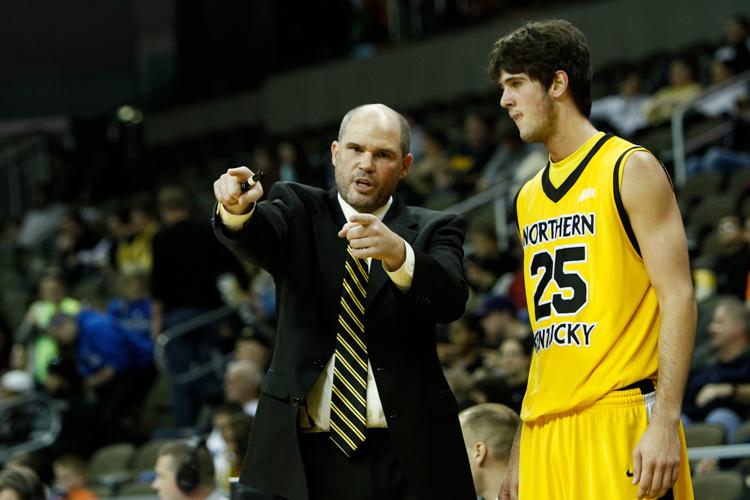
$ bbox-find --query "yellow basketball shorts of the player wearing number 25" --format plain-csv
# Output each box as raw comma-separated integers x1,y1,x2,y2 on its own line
519,389,693,500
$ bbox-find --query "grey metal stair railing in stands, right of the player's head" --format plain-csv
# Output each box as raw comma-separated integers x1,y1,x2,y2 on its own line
672,70,750,187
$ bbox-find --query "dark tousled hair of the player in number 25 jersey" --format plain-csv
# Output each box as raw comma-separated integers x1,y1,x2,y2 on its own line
489,19,593,117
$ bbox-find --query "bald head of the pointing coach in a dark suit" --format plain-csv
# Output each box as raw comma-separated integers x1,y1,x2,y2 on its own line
331,106,413,213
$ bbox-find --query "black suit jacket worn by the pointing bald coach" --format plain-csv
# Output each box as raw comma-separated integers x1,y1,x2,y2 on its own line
214,182,476,500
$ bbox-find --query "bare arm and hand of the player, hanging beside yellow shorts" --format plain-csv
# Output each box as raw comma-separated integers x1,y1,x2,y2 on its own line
621,152,696,498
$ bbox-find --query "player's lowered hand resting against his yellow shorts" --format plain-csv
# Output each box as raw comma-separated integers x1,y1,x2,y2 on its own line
633,419,680,499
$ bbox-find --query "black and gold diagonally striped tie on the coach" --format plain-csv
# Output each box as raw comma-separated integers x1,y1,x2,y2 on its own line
330,246,368,457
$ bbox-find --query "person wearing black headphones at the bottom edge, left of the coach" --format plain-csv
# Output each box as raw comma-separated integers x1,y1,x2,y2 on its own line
151,438,228,500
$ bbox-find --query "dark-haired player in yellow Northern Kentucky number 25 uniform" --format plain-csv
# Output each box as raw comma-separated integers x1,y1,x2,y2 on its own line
490,20,696,500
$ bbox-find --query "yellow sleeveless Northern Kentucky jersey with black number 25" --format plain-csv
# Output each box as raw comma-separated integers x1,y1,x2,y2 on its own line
516,133,659,422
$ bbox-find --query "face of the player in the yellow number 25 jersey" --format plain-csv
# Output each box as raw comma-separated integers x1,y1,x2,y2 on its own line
498,71,557,142
